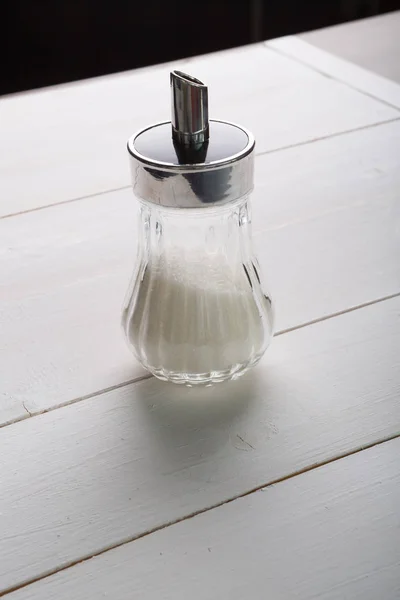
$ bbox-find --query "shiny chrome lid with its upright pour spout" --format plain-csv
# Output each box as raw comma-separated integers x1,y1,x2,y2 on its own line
128,71,255,208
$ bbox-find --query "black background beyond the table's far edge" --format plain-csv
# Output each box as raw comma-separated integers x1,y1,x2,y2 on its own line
0,0,400,94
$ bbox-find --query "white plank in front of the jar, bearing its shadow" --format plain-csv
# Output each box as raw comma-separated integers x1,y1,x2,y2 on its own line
0,298,400,597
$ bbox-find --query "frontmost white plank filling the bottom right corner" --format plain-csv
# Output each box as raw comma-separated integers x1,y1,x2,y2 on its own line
10,439,400,600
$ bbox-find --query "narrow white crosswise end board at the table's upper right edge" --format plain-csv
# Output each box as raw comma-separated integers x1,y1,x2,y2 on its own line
266,36,400,108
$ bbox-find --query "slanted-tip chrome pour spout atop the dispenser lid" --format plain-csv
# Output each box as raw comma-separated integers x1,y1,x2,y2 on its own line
171,71,209,150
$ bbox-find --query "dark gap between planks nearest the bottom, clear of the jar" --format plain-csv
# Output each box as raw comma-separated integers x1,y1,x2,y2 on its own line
0,432,400,598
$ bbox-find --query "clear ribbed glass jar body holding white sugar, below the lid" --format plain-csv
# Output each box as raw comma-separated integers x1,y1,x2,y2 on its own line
122,198,273,385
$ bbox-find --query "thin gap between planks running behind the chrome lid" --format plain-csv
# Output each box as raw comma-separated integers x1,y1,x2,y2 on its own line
0,115,400,220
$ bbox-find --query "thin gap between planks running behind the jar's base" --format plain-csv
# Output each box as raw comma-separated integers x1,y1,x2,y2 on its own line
0,292,400,428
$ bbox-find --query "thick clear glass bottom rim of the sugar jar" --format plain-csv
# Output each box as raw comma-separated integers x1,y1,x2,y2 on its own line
146,352,264,387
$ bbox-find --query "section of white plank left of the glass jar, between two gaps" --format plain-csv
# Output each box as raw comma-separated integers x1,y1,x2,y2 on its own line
0,195,145,423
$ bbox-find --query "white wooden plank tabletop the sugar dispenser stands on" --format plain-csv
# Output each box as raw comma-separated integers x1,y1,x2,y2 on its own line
0,14,400,600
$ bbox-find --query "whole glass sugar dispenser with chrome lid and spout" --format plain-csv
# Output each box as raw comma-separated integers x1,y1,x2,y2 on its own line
122,71,273,385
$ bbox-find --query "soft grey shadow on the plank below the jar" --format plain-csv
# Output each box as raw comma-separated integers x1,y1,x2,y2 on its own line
135,371,259,468
